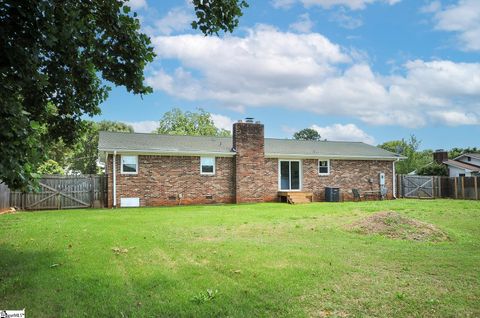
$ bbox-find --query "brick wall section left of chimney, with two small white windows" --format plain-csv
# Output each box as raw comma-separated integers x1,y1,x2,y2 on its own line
107,155,235,207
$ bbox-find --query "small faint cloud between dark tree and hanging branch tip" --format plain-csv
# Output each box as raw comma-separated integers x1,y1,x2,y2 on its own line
153,7,194,35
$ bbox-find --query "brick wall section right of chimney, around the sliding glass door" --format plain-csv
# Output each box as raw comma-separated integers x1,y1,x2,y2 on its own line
264,158,393,201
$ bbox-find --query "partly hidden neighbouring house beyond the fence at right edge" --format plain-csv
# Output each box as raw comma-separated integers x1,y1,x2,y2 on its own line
433,149,480,177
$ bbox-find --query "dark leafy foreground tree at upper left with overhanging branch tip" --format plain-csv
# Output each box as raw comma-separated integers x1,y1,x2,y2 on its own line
0,0,246,189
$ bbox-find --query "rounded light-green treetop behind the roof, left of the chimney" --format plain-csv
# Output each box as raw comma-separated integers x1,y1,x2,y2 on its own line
156,108,230,136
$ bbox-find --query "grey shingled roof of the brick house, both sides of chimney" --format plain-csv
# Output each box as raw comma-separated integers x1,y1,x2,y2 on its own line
98,131,404,160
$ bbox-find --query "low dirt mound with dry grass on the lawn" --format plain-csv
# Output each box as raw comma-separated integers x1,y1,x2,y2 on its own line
347,211,449,242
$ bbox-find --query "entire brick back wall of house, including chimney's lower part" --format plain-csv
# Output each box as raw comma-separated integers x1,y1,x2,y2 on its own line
107,153,392,207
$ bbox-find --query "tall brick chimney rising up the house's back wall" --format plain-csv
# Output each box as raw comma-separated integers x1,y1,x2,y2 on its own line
233,118,265,203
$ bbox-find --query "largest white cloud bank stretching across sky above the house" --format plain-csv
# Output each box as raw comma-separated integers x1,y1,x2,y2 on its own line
147,26,480,127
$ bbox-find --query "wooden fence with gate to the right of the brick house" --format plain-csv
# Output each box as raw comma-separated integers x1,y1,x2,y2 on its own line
397,175,480,200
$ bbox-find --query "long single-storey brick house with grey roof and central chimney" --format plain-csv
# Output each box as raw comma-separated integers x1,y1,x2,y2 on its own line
99,121,403,206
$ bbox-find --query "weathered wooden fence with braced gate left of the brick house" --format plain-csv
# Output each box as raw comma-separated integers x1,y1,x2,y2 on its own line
10,175,107,210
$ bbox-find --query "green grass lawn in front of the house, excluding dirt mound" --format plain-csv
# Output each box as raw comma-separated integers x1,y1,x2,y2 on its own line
0,200,480,317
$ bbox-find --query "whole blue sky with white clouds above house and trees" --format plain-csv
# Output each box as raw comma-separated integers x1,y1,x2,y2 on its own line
96,0,480,149
